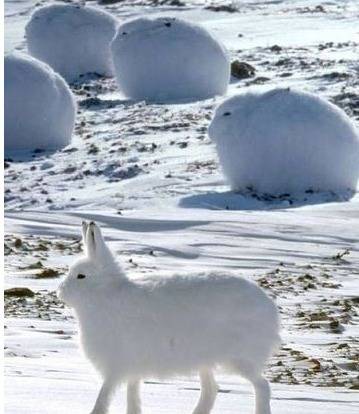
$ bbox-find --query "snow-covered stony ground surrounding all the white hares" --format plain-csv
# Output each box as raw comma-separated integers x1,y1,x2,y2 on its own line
5,0,359,414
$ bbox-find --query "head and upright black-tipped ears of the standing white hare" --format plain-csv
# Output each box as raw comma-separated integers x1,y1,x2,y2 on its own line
58,222,122,307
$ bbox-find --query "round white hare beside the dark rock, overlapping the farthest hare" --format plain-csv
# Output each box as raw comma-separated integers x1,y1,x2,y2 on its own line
111,17,230,102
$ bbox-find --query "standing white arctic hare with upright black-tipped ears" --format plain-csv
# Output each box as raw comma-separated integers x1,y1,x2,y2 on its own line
59,222,279,414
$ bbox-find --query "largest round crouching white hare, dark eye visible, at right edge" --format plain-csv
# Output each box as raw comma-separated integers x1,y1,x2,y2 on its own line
209,88,359,195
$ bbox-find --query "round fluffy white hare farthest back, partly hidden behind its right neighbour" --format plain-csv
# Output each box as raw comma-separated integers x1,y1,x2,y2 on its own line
26,4,118,82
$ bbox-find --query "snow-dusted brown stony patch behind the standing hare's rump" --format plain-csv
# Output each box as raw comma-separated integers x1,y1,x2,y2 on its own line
257,254,359,389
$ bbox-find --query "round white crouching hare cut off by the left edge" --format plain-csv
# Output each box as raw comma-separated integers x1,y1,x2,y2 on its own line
4,53,76,151
